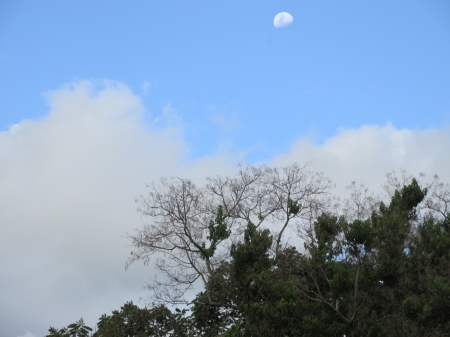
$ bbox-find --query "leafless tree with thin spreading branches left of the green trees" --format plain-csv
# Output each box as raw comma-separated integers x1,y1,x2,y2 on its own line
127,164,333,305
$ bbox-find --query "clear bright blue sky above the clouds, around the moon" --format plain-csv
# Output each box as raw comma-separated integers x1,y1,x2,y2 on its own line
0,1,450,161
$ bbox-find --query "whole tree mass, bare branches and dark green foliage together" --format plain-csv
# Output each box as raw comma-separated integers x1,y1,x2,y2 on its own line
49,165,450,337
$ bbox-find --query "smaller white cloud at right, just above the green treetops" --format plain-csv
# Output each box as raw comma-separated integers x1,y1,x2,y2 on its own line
272,123,450,195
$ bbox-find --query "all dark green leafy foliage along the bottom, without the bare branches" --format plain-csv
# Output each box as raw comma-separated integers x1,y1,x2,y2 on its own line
48,180,450,337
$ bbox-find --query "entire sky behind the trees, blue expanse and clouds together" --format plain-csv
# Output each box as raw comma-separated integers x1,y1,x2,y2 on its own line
0,0,450,337
